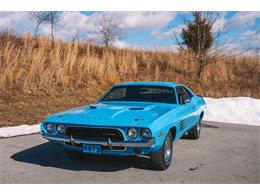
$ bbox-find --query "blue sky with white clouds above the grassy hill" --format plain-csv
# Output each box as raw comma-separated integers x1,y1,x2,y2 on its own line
0,11,260,50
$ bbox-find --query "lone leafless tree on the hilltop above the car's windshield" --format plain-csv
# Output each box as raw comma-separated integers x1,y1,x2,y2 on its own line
97,13,122,47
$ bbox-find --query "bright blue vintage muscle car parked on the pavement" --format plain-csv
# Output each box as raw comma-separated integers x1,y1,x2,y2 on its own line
41,82,205,170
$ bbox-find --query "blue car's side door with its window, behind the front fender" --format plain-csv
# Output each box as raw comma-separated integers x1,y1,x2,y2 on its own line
176,86,195,133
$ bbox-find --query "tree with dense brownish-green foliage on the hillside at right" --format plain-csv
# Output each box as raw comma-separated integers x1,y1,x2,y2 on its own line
175,12,226,79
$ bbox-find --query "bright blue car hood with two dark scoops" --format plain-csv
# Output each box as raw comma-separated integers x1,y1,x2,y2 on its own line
45,102,177,127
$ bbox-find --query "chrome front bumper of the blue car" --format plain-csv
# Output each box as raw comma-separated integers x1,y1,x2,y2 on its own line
43,135,155,147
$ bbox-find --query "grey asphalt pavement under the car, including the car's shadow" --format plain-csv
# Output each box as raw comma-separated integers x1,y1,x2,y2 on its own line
0,122,260,183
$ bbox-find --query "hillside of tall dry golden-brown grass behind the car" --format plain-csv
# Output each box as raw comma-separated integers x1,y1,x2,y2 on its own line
0,33,260,126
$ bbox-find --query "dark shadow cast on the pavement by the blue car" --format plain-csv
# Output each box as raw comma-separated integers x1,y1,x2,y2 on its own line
11,142,153,172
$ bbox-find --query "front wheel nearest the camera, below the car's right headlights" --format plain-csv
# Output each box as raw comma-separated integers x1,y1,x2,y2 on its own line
151,131,173,170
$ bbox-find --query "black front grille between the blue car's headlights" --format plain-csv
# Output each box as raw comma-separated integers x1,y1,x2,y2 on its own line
65,127,124,141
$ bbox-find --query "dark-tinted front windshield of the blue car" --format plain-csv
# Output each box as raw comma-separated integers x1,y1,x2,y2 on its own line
101,85,176,104
